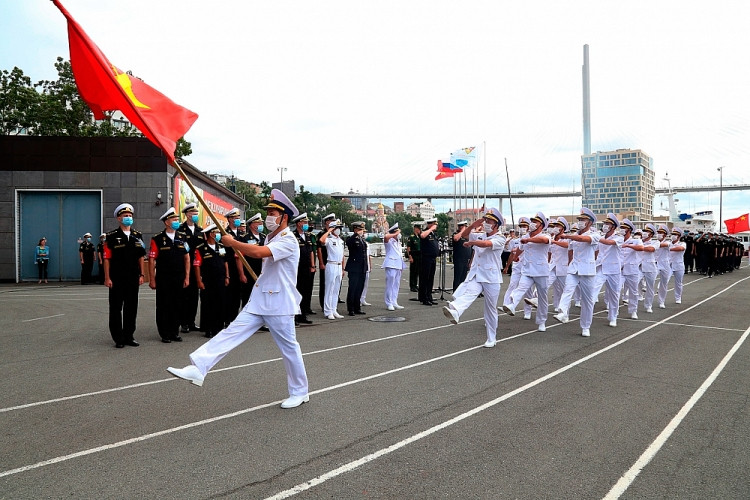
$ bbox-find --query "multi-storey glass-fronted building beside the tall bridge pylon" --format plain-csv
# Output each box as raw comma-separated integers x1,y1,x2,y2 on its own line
581,149,654,220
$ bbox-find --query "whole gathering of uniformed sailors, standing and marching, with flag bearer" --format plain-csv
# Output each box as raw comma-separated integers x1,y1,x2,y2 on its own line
97,197,744,408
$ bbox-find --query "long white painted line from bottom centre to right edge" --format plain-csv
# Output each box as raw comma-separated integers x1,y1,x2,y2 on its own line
266,278,750,500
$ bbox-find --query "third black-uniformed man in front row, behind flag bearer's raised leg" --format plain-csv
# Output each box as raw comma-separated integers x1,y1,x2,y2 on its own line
193,224,229,339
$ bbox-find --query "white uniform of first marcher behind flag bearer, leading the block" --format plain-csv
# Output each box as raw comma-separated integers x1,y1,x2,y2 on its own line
448,231,505,342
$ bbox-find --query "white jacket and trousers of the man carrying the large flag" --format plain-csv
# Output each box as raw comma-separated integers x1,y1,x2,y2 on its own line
190,229,308,396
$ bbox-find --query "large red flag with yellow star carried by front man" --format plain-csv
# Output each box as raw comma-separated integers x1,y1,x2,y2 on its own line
52,0,198,163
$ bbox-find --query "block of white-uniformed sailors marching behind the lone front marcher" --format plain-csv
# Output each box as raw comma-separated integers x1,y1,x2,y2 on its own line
502,208,716,337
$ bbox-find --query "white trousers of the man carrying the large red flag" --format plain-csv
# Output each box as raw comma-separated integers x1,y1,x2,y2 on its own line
190,310,308,396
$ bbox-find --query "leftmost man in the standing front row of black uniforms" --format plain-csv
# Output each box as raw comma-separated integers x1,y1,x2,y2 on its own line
104,203,146,348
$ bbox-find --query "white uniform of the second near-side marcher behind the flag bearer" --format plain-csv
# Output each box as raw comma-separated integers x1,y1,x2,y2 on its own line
505,233,550,325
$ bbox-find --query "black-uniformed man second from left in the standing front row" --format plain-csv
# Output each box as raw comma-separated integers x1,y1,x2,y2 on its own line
148,207,190,344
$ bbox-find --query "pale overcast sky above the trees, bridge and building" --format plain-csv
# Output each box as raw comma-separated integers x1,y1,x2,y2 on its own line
0,0,750,229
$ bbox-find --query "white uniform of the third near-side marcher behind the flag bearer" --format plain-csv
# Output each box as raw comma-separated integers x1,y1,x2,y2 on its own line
560,229,600,330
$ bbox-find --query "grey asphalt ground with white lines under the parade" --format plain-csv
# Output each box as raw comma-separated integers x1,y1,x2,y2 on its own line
0,259,750,499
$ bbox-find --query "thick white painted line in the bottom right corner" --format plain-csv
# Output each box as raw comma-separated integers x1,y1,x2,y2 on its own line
604,322,750,500
